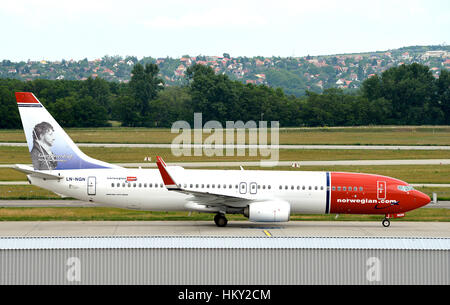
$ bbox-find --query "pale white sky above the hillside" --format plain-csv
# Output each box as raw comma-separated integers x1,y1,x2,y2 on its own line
0,0,450,61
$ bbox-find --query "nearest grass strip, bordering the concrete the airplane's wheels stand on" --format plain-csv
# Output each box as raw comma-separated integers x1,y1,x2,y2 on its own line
0,208,450,222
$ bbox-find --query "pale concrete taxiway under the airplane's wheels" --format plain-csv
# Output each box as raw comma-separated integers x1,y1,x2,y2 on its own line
0,220,450,238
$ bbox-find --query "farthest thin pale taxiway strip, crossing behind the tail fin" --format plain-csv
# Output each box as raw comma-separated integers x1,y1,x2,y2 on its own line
0,142,450,150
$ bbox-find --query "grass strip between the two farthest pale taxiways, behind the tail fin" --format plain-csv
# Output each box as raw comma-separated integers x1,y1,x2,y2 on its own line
0,146,450,164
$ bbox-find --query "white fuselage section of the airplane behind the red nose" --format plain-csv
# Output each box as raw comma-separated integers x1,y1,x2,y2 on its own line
29,167,327,214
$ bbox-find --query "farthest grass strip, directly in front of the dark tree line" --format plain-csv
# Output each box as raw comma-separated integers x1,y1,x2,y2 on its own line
0,126,450,145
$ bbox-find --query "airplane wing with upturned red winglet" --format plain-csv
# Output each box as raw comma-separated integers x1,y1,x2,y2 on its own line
156,156,254,208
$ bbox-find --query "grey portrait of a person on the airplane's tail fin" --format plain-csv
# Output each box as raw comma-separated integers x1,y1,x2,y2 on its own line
31,122,58,170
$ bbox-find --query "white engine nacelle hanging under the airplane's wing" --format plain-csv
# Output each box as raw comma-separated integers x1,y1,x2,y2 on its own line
244,200,291,222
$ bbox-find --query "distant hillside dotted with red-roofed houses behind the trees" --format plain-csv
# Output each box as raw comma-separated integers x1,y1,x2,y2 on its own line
0,46,450,96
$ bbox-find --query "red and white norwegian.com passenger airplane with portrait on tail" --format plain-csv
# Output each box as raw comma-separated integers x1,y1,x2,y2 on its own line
15,92,431,227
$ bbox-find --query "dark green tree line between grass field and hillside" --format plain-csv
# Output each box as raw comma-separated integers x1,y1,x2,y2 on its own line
0,63,450,128
